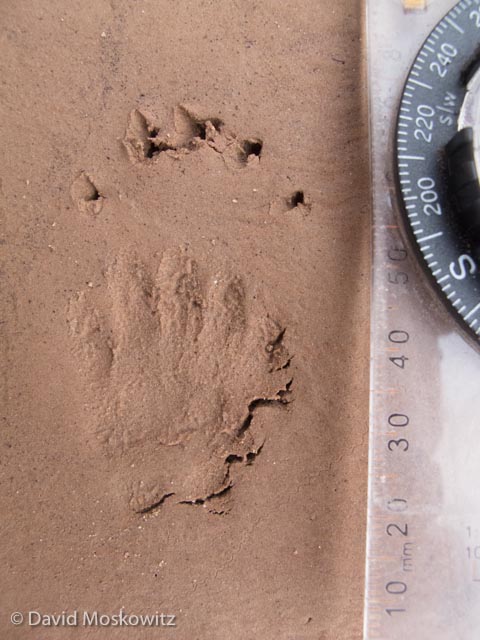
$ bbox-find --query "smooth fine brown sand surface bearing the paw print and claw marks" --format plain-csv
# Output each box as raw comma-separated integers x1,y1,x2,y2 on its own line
0,0,370,640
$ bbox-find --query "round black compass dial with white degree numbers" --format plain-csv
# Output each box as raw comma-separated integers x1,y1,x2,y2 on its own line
396,0,480,339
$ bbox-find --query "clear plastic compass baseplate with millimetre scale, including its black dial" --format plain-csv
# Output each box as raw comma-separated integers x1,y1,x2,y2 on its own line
364,0,480,640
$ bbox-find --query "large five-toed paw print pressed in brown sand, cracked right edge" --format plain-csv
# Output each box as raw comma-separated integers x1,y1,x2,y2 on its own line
68,250,292,512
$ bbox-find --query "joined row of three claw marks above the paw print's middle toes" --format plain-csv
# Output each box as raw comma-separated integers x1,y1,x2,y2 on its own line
123,105,263,167
